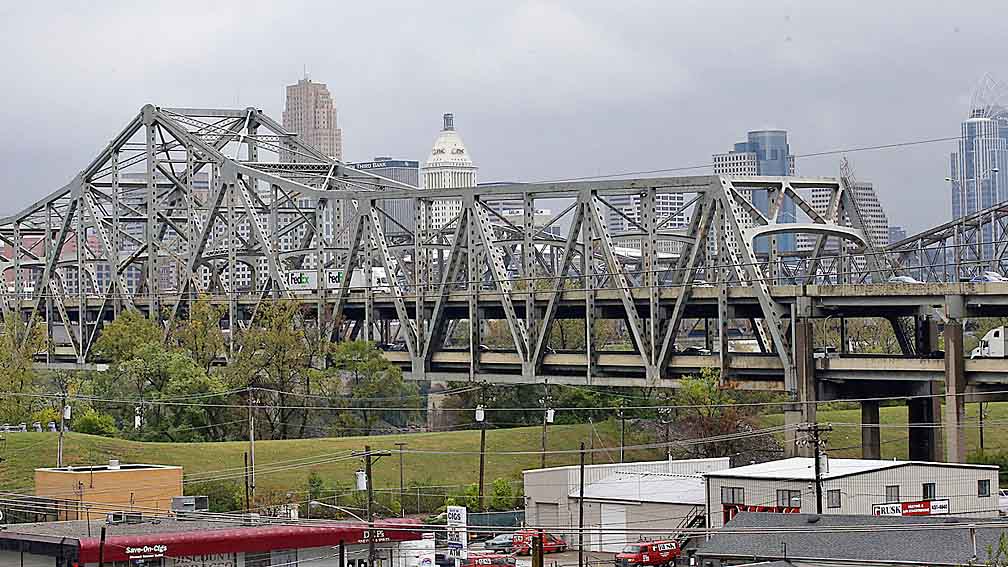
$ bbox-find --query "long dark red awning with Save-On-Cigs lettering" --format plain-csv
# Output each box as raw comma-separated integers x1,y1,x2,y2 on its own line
79,521,421,563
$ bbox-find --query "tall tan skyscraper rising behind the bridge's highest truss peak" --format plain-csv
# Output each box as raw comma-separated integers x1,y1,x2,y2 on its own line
280,78,343,161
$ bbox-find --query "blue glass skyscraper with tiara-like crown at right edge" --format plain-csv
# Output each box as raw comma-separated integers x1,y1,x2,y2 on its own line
948,76,1008,257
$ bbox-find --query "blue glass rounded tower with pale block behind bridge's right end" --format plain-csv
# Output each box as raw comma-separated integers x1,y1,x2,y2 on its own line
714,130,796,253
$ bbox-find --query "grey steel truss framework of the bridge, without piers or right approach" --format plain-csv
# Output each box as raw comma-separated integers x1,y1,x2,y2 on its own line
0,106,874,385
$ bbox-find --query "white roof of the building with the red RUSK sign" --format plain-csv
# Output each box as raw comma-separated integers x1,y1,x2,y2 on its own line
706,457,998,480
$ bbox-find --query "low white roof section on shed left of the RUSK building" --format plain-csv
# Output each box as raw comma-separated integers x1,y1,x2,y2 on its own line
568,472,707,504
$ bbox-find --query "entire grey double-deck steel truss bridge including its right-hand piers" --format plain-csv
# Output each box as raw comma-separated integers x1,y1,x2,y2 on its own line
0,105,1008,460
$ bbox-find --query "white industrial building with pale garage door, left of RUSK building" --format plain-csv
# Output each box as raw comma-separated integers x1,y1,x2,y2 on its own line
524,457,730,552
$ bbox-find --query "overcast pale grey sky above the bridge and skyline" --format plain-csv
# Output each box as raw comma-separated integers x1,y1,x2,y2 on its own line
0,0,1008,230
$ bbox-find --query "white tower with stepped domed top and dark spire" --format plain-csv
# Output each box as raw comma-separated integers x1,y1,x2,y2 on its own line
421,113,479,228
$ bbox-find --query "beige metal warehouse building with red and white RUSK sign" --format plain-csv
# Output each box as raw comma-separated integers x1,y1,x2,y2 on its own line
707,451,998,528
